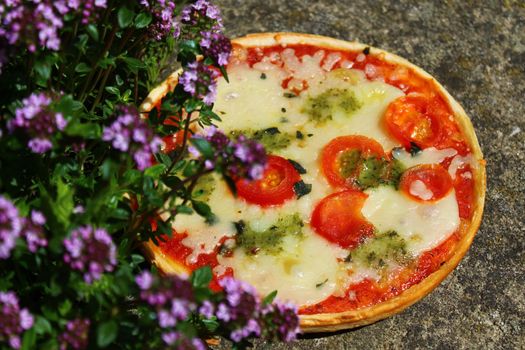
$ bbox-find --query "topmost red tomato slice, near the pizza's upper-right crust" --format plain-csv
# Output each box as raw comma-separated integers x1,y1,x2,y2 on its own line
385,94,443,148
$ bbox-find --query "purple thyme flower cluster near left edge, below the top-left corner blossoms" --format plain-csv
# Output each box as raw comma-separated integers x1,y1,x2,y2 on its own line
7,93,67,153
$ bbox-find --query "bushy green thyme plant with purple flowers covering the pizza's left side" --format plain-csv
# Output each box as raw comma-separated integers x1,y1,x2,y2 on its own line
0,0,299,349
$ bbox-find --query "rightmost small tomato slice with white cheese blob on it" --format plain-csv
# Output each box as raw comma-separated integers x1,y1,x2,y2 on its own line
399,164,453,202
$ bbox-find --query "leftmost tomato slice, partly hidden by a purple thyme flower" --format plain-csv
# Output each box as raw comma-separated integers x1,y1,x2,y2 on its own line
236,155,301,207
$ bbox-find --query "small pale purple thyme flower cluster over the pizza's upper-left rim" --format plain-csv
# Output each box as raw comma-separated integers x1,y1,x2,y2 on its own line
179,61,219,105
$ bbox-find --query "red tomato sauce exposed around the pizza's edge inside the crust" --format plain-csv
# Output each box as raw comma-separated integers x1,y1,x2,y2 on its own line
160,45,474,315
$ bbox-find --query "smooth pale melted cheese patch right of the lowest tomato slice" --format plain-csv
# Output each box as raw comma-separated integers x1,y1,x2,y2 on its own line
361,186,460,256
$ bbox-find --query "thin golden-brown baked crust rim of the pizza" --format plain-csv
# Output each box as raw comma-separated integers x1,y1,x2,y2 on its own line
140,33,486,333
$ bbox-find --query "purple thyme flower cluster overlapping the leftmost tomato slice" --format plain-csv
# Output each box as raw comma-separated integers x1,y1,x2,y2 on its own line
189,126,267,180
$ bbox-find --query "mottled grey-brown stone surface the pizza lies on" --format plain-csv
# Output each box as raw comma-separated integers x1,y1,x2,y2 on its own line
216,0,525,350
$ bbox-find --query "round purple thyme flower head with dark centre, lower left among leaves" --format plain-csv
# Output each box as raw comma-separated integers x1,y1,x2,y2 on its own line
64,226,117,283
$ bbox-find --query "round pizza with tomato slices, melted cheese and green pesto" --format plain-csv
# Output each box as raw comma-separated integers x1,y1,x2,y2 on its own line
143,33,486,332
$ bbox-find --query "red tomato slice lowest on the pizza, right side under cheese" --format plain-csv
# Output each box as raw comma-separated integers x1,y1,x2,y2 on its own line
310,190,374,248
